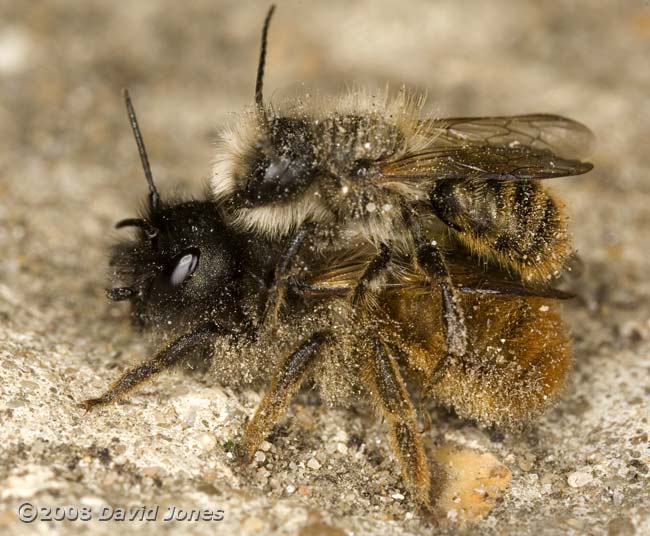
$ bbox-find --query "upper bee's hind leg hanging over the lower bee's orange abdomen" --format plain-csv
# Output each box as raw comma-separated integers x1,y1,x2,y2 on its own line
417,241,467,355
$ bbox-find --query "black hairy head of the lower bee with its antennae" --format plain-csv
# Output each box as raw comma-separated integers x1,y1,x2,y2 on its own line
107,92,241,329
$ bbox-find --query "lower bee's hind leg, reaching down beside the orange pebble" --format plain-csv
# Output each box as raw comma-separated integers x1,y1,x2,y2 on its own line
365,339,434,511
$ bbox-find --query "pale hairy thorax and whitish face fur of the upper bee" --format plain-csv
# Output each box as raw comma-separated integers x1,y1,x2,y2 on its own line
211,89,433,243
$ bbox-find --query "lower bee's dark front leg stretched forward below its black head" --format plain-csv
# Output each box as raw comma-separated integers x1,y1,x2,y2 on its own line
79,323,224,411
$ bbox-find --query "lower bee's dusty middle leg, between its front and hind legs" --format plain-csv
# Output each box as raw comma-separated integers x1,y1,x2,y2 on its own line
240,331,331,460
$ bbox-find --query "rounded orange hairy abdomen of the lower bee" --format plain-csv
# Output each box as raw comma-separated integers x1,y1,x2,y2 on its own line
390,292,571,426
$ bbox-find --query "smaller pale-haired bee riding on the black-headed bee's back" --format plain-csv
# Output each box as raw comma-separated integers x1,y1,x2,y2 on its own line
211,6,593,355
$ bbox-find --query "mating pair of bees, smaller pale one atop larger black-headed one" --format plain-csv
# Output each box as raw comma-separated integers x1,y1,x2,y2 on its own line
83,8,592,510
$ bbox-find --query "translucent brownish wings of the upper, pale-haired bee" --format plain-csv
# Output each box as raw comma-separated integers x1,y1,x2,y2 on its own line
378,114,594,182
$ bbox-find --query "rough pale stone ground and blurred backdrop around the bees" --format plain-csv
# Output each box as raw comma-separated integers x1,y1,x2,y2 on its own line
0,0,650,535
